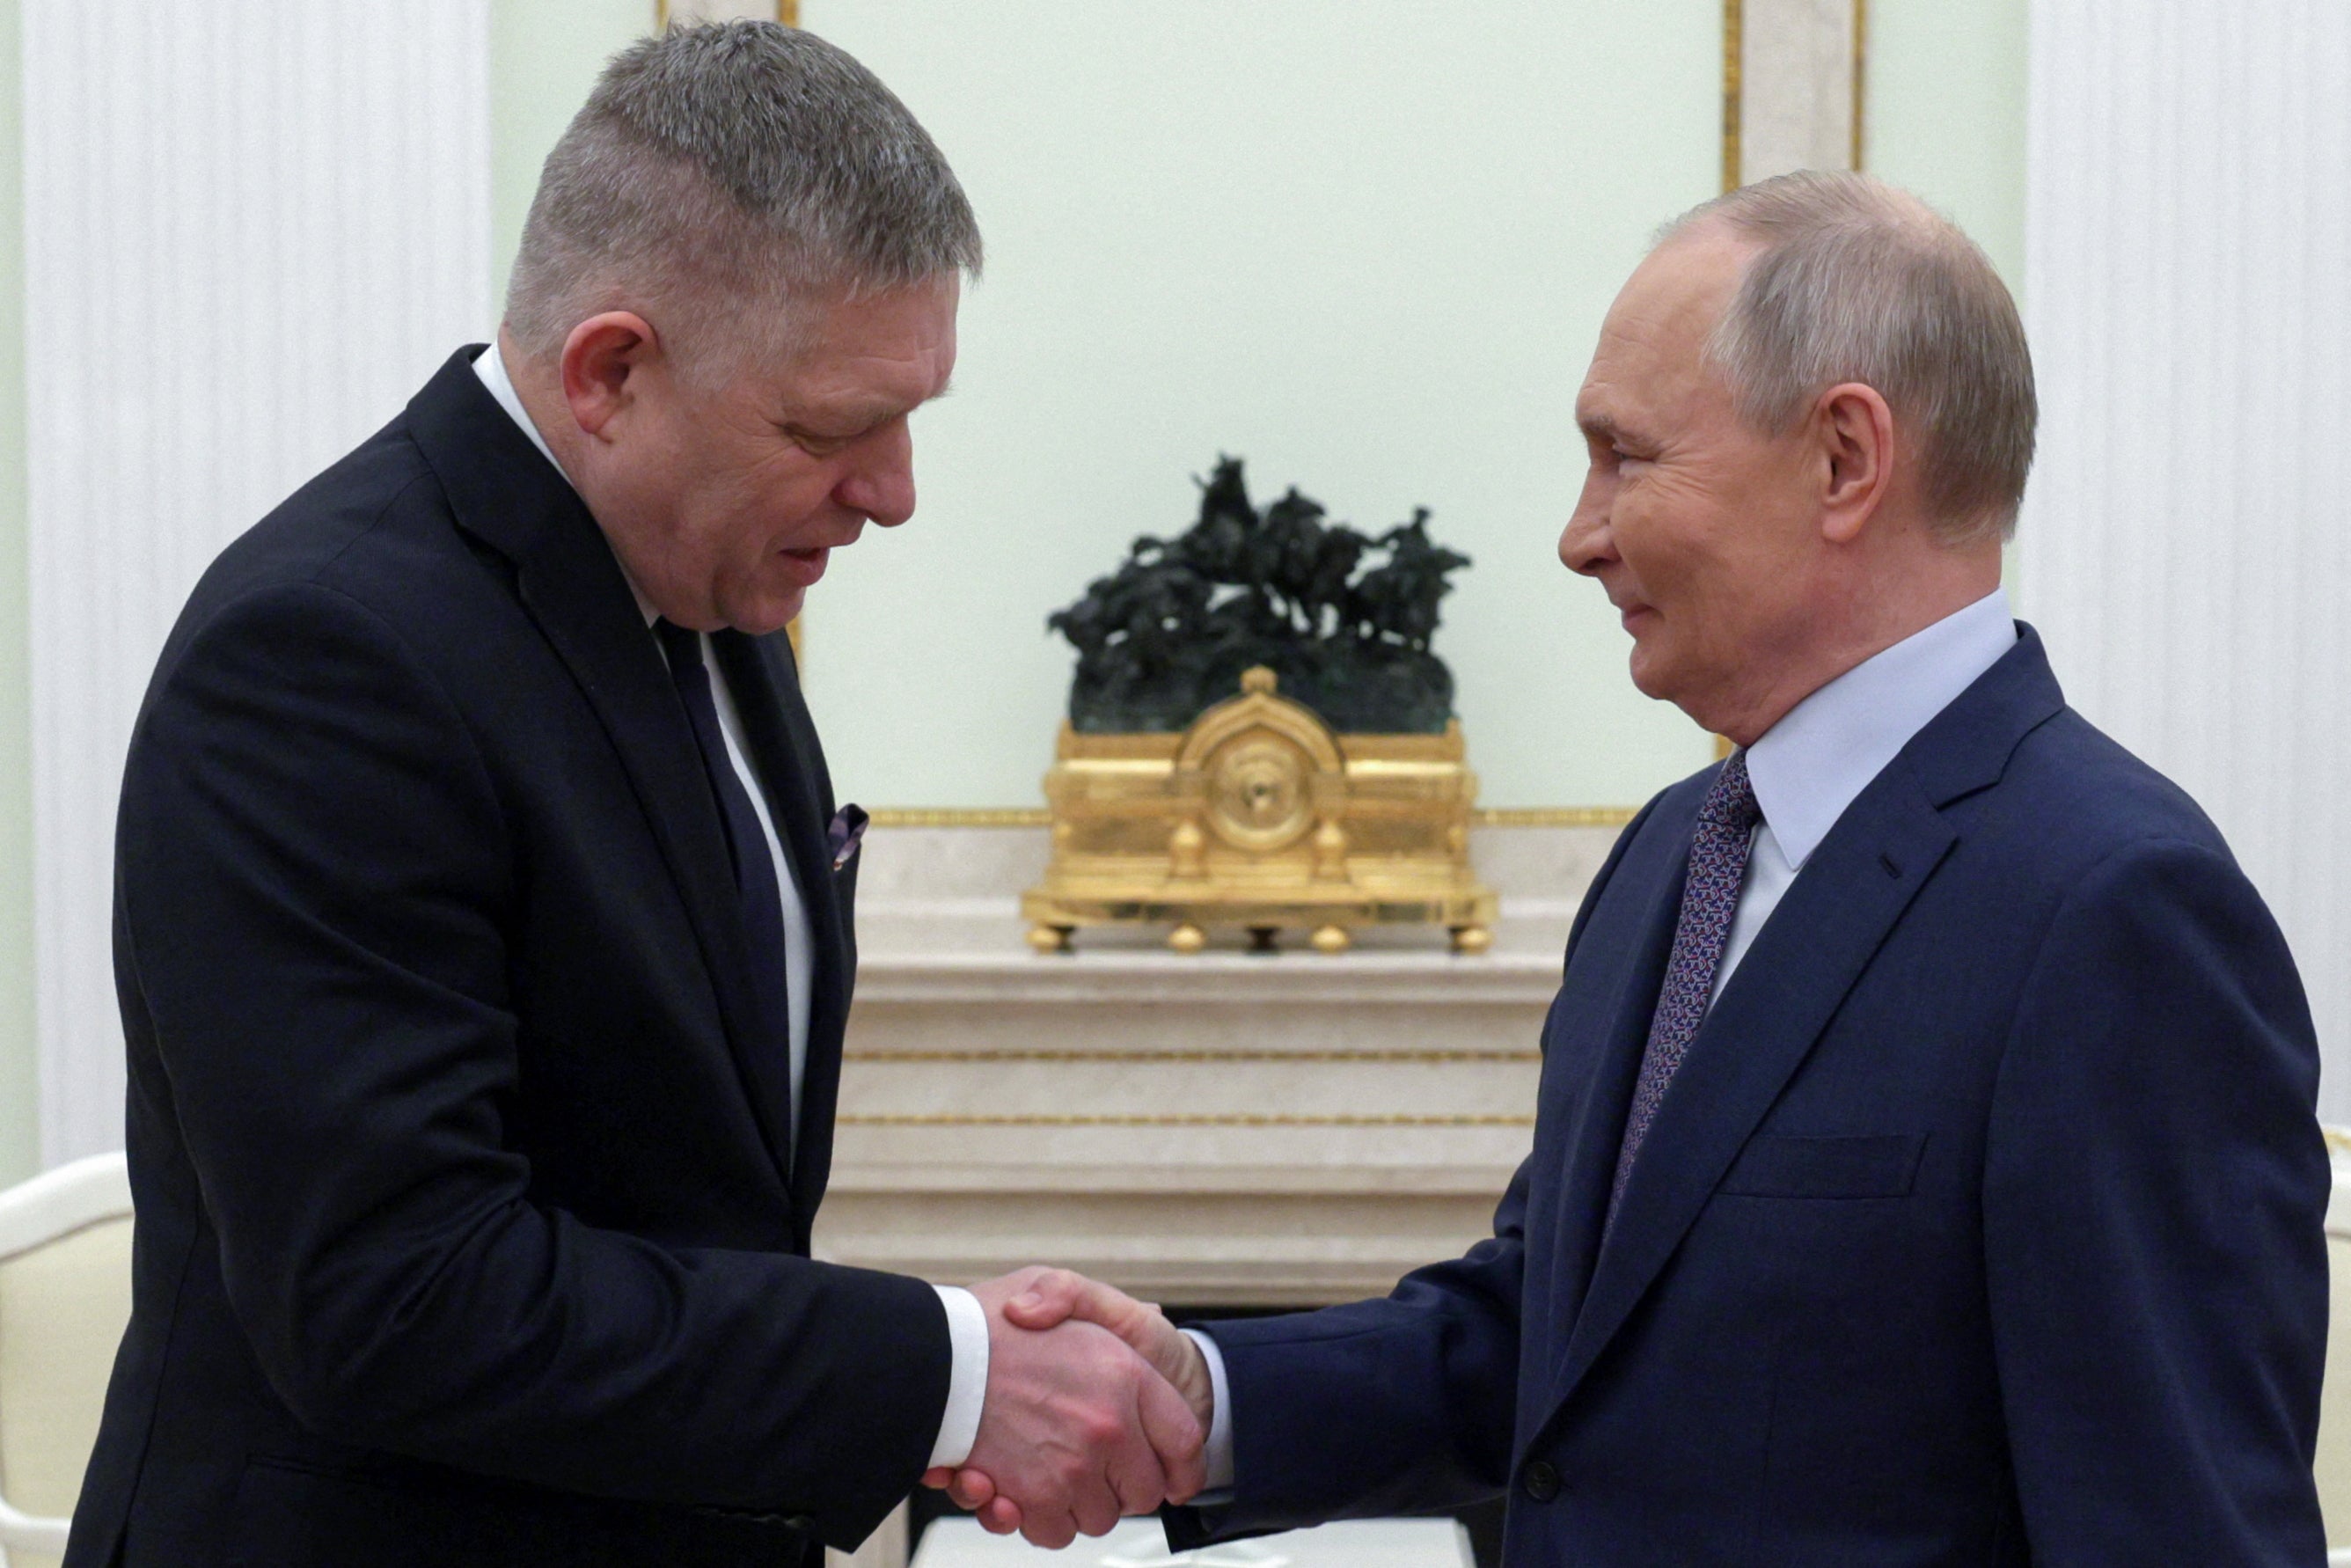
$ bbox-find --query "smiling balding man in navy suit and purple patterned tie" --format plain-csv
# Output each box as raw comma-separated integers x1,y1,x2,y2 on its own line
992,174,2330,1568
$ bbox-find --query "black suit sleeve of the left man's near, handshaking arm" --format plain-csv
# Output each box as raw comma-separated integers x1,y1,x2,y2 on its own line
118,585,949,1544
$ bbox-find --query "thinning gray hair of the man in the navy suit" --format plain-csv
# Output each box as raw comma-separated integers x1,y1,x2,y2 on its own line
1659,169,2040,546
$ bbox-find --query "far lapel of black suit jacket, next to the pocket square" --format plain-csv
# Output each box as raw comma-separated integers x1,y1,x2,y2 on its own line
710,633,849,1218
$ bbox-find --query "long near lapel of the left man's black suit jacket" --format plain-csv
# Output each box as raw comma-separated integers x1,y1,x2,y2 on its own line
409,350,792,1183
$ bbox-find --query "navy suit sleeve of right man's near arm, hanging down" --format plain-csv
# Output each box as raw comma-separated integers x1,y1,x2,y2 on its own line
1984,844,2327,1568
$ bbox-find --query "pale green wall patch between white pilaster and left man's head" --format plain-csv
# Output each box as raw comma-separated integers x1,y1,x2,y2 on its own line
484,0,655,322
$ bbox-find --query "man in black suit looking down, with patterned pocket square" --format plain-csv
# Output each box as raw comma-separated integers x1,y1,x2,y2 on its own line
68,24,1201,1568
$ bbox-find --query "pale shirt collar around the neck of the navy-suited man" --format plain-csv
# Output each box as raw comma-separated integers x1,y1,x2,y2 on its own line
1747,588,2018,870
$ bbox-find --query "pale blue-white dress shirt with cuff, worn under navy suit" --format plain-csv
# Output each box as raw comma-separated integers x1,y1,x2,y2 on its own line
1185,588,2018,1502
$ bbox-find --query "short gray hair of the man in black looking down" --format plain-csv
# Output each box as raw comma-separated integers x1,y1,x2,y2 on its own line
505,21,980,364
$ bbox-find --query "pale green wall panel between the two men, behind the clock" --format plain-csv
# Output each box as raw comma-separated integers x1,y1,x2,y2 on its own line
802,0,1721,806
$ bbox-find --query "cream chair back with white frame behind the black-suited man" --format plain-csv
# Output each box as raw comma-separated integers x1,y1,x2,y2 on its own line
0,1154,132,1568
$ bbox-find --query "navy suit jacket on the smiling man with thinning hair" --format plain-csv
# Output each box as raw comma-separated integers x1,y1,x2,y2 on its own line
1171,627,2327,1568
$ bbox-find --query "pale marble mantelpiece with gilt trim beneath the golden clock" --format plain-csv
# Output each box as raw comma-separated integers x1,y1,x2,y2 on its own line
818,827,1615,1307
